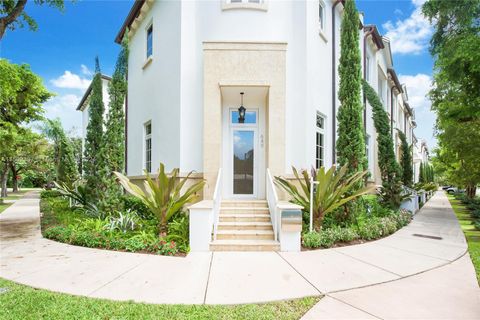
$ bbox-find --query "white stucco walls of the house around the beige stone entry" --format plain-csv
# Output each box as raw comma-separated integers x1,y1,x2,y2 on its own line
127,0,420,190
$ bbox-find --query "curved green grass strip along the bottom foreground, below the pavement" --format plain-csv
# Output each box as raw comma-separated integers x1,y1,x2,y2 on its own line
0,278,320,320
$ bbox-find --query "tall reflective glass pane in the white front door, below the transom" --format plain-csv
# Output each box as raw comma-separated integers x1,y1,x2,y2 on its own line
233,130,255,195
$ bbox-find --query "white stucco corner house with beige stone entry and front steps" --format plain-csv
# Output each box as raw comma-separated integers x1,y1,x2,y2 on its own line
80,0,426,251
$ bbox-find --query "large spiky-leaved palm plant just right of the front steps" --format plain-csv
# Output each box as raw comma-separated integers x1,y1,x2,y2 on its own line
275,165,373,230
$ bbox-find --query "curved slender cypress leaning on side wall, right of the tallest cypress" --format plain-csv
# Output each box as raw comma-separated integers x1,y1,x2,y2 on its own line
363,80,402,209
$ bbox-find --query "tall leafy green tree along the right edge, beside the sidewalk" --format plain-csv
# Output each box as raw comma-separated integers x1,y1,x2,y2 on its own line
422,0,480,197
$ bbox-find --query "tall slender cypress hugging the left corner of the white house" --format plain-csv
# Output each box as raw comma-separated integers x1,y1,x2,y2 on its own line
101,38,128,211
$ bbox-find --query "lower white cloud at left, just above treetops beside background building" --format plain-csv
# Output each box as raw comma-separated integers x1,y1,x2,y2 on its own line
43,94,82,135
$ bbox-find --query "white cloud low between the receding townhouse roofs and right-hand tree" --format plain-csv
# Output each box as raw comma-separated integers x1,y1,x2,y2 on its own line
398,73,436,148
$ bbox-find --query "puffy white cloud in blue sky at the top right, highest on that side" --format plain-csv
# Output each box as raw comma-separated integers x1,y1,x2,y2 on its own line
383,0,433,54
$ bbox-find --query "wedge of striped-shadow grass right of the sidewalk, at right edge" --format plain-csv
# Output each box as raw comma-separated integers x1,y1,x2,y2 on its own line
448,194,480,284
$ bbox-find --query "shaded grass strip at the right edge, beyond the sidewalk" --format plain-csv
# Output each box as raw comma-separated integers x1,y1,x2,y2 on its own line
448,195,480,285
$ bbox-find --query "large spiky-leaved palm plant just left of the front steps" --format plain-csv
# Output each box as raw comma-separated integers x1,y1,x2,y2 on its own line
115,163,205,236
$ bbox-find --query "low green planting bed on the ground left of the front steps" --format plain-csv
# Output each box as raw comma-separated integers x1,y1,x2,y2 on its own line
40,191,188,256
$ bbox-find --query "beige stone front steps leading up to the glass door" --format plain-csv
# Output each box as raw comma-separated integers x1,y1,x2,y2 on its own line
210,200,280,251
